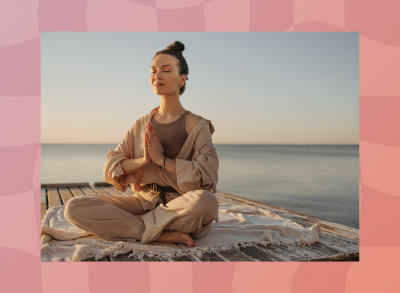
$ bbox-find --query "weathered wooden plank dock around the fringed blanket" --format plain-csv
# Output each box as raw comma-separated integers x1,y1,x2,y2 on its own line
41,182,359,262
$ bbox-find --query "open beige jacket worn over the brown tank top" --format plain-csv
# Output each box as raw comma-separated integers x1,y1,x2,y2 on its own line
103,107,219,209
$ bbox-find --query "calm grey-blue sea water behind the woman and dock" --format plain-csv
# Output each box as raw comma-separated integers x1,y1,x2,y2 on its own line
41,144,359,228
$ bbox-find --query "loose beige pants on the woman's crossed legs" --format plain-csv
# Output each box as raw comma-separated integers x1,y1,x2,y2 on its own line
64,190,219,244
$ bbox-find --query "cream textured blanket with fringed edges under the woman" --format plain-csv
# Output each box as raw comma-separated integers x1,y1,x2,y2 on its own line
41,197,321,261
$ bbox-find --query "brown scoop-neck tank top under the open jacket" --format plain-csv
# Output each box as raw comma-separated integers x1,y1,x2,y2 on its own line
151,111,190,159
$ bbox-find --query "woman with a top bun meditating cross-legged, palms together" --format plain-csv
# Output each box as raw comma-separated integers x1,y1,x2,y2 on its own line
64,41,219,246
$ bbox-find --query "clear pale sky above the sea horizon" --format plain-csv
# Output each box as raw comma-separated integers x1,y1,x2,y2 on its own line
41,32,359,144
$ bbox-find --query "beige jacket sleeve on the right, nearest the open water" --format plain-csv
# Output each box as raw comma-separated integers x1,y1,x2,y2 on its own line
176,124,219,193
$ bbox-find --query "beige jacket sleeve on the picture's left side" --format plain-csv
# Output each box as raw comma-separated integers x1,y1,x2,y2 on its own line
103,128,134,192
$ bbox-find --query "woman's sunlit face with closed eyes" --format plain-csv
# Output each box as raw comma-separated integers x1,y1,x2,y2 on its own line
149,54,182,95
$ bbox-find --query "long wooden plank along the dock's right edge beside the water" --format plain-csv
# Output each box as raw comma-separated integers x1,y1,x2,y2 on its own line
219,194,359,239
